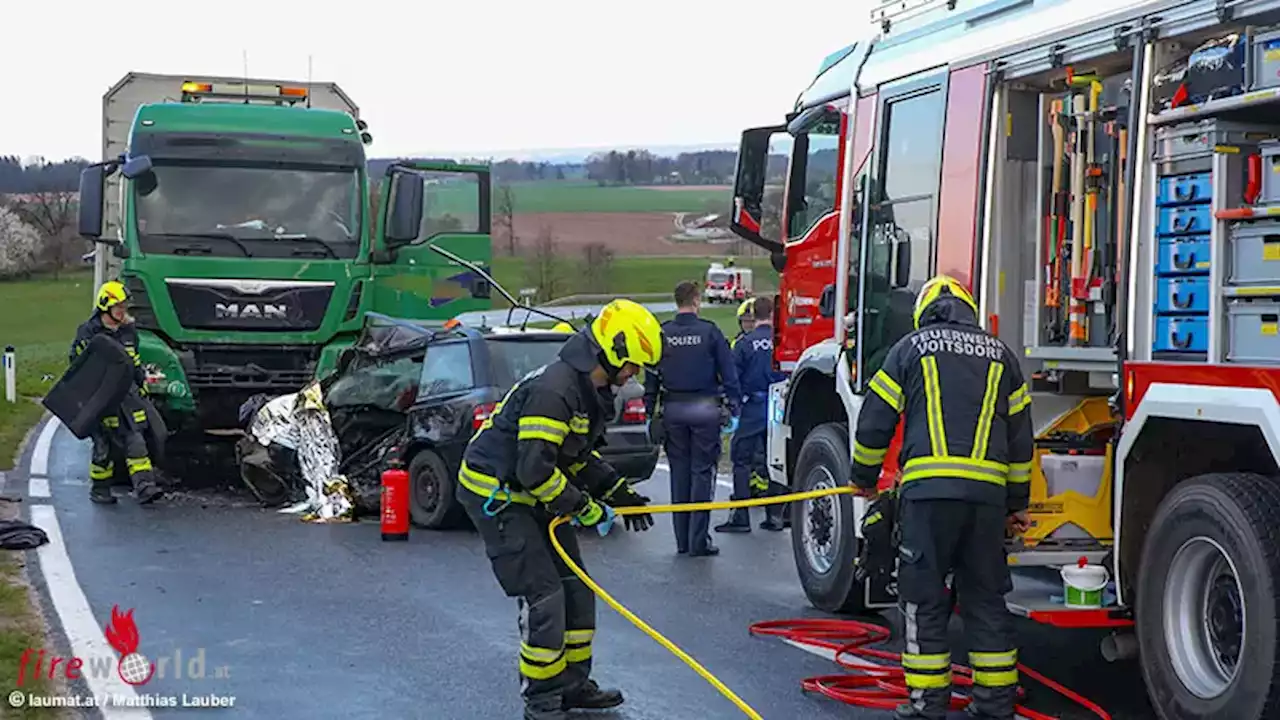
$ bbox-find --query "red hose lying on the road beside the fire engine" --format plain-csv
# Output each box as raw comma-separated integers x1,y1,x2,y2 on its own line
751,620,1111,720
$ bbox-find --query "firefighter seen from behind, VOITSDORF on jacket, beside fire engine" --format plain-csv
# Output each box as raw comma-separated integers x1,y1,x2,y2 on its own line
852,275,1033,720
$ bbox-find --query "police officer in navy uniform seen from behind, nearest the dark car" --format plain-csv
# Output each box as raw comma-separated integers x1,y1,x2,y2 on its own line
645,282,741,556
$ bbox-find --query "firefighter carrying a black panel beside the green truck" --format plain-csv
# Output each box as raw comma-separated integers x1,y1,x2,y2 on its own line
69,281,164,505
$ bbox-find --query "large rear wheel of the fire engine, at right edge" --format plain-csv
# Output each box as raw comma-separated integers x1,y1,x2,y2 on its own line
1137,473,1280,720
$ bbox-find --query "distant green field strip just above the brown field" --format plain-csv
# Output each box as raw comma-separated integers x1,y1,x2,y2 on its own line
426,181,730,217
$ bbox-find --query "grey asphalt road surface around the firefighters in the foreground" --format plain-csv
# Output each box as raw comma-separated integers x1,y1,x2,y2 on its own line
0,415,1152,720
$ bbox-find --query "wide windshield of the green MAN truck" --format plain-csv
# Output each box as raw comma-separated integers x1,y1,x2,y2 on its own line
133,164,361,259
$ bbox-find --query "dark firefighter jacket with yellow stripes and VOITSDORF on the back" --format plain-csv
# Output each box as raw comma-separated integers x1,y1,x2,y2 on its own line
854,300,1034,512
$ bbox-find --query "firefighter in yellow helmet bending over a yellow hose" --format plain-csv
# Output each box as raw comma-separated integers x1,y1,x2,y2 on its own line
457,300,664,720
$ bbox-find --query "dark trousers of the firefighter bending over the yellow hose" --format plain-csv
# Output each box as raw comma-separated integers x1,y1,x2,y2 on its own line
458,491,595,707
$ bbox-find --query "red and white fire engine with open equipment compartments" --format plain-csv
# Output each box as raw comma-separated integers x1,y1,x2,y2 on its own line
731,0,1280,719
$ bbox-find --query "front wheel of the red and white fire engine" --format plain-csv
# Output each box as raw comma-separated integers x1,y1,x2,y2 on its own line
791,423,867,614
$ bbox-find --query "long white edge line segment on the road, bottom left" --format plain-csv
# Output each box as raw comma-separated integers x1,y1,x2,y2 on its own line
31,502,151,720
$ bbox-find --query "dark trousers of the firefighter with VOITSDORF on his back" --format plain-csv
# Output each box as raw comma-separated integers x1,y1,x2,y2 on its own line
897,498,1018,720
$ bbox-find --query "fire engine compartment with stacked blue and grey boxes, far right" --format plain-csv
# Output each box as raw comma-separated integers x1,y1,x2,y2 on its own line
1134,27,1280,365
